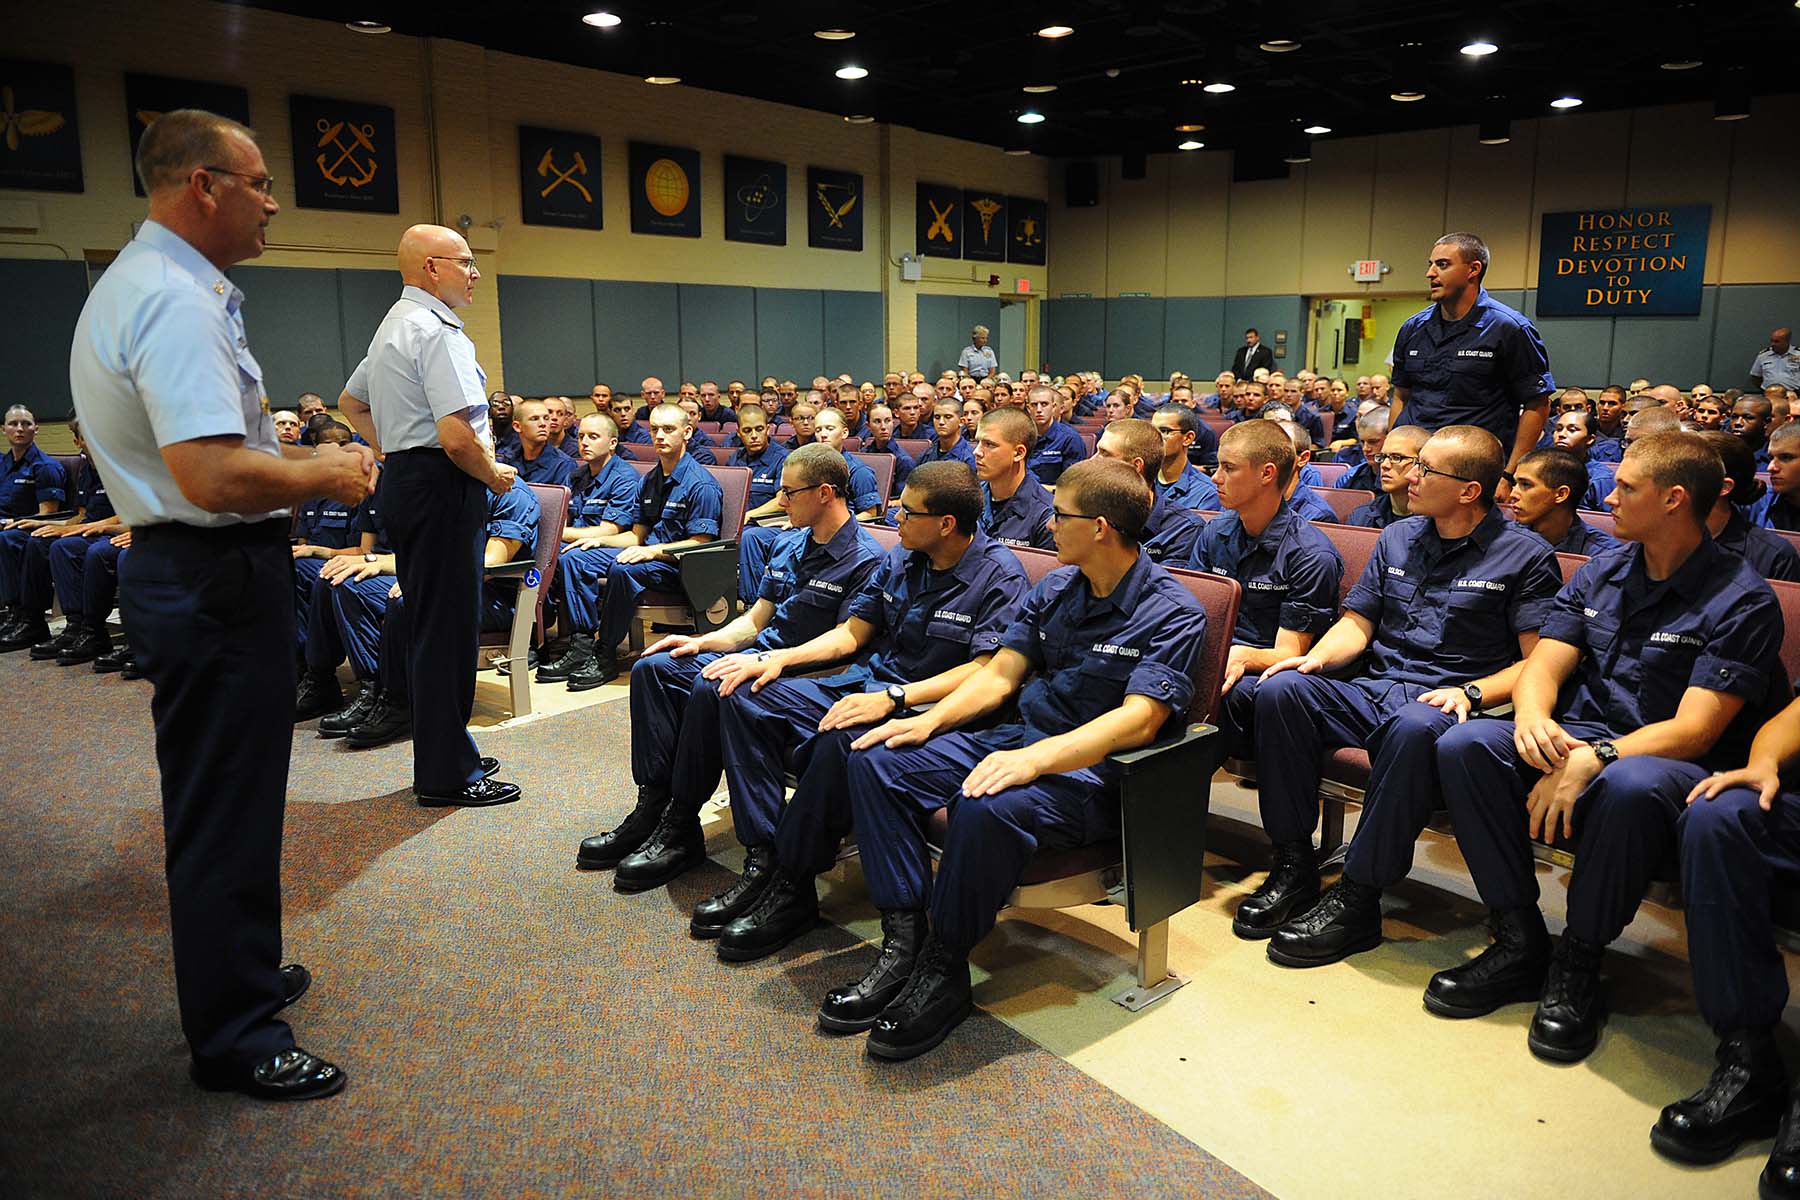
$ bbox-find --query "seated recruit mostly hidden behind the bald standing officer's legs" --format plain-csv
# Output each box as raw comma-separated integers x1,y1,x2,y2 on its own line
329,471,540,748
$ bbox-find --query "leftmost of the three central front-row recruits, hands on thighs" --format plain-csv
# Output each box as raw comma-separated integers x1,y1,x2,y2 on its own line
576,446,882,891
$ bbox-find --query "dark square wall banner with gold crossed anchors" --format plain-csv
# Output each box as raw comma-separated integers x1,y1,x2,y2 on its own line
288,95,400,212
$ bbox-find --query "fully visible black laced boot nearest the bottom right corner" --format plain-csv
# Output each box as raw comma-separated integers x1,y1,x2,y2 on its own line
1651,1029,1787,1164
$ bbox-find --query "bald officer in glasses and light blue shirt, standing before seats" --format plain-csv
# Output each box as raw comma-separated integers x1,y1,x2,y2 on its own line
340,225,518,808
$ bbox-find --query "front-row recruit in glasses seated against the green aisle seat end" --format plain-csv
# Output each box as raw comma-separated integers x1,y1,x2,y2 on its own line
819,456,1206,1058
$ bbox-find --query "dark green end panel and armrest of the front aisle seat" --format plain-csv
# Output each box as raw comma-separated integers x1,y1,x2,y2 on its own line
1107,725,1226,930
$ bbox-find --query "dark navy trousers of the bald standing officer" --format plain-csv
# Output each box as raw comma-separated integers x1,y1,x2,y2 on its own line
382,450,488,793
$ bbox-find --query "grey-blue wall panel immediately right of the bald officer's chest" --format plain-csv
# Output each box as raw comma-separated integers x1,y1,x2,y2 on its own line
500,275,597,396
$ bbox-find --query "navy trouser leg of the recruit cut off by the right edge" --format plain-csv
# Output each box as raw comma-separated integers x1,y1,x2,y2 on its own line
1677,788,1800,1036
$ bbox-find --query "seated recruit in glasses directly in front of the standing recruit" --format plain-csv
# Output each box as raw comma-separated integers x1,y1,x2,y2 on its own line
1224,425,1562,942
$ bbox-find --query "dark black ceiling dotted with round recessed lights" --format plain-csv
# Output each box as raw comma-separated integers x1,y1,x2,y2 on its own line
239,0,1800,167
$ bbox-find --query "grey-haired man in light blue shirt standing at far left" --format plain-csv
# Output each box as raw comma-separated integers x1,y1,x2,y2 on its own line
68,110,374,1099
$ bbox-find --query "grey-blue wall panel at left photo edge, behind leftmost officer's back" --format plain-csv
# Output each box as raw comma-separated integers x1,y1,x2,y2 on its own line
0,259,86,421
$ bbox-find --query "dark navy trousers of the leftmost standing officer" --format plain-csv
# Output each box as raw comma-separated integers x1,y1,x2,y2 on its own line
121,520,295,1069
